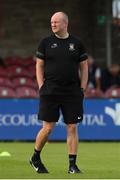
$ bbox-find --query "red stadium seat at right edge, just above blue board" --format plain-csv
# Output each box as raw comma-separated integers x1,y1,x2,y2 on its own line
105,87,120,98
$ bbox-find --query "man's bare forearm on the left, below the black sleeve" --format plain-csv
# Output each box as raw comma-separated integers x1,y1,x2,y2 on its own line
36,58,44,89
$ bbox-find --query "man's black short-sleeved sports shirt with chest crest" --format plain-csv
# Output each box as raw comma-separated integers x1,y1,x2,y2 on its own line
36,35,87,95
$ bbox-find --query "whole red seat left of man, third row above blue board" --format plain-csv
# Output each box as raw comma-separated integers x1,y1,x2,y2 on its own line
6,65,31,78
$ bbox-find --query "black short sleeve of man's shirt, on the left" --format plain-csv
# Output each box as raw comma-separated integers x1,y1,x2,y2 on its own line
36,39,45,60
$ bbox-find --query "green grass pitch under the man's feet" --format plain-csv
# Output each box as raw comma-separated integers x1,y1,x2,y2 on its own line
0,142,120,179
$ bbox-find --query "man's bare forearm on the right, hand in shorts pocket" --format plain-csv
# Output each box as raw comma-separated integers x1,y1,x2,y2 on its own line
80,59,88,91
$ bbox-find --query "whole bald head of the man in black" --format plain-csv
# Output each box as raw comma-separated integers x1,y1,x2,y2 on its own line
51,12,68,35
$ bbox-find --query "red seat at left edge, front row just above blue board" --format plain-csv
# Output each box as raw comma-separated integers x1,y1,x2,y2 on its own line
0,86,16,98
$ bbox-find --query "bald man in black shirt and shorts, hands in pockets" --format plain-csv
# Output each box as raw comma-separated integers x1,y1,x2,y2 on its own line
30,12,88,173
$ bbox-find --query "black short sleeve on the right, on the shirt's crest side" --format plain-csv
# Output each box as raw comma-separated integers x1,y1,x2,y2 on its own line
79,42,88,61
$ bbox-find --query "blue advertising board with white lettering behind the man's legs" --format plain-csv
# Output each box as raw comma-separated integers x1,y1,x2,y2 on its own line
0,99,120,140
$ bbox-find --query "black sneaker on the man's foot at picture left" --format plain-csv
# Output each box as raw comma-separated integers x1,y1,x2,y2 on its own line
30,158,49,173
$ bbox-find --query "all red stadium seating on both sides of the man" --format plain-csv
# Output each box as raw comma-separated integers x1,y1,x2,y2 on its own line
0,56,120,98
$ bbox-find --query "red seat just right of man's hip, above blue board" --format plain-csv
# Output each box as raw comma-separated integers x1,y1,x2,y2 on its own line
85,88,104,98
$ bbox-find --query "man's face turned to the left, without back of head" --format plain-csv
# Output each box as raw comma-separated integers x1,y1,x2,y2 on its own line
51,14,66,34
